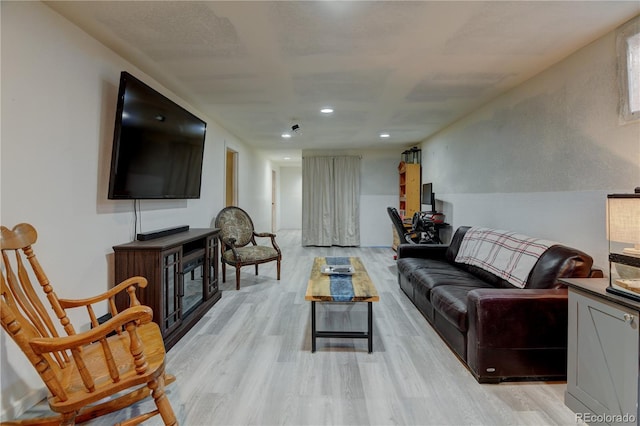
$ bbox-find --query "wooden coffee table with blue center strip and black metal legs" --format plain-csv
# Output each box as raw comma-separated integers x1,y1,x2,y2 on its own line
304,257,380,353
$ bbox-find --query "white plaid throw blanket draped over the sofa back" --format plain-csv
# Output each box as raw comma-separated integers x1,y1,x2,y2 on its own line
456,227,556,288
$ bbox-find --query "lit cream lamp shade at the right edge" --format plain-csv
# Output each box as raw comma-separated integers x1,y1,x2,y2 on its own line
607,196,640,244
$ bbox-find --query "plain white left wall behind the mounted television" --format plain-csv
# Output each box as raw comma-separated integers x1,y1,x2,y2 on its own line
0,2,271,419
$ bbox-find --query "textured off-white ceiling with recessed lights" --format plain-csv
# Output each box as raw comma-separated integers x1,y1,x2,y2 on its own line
46,0,640,163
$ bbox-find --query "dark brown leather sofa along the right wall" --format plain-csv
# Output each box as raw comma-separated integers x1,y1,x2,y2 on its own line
397,227,602,383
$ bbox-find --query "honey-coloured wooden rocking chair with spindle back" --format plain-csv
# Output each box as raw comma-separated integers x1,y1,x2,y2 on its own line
0,223,177,425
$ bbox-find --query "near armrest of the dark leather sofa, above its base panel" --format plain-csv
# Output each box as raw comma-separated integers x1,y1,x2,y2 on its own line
467,288,568,348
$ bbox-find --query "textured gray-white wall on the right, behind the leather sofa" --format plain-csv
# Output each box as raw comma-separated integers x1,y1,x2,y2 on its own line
422,24,640,273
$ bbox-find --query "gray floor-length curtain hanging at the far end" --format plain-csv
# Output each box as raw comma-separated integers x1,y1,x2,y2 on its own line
302,156,360,247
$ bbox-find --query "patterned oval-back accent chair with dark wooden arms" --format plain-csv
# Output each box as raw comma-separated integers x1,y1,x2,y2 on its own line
215,206,282,290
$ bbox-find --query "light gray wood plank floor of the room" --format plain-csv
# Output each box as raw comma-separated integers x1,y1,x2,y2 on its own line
27,231,577,426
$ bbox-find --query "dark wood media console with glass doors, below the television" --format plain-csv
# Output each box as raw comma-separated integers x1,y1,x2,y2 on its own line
113,228,221,350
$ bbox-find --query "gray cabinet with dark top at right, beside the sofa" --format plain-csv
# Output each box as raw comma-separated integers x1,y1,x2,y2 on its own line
564,279,640,425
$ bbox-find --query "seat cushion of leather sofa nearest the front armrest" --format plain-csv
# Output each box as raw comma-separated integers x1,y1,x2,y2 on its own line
431,279,492,333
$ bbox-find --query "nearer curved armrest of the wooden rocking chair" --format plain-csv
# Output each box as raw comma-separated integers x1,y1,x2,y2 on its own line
29,305,153,354
